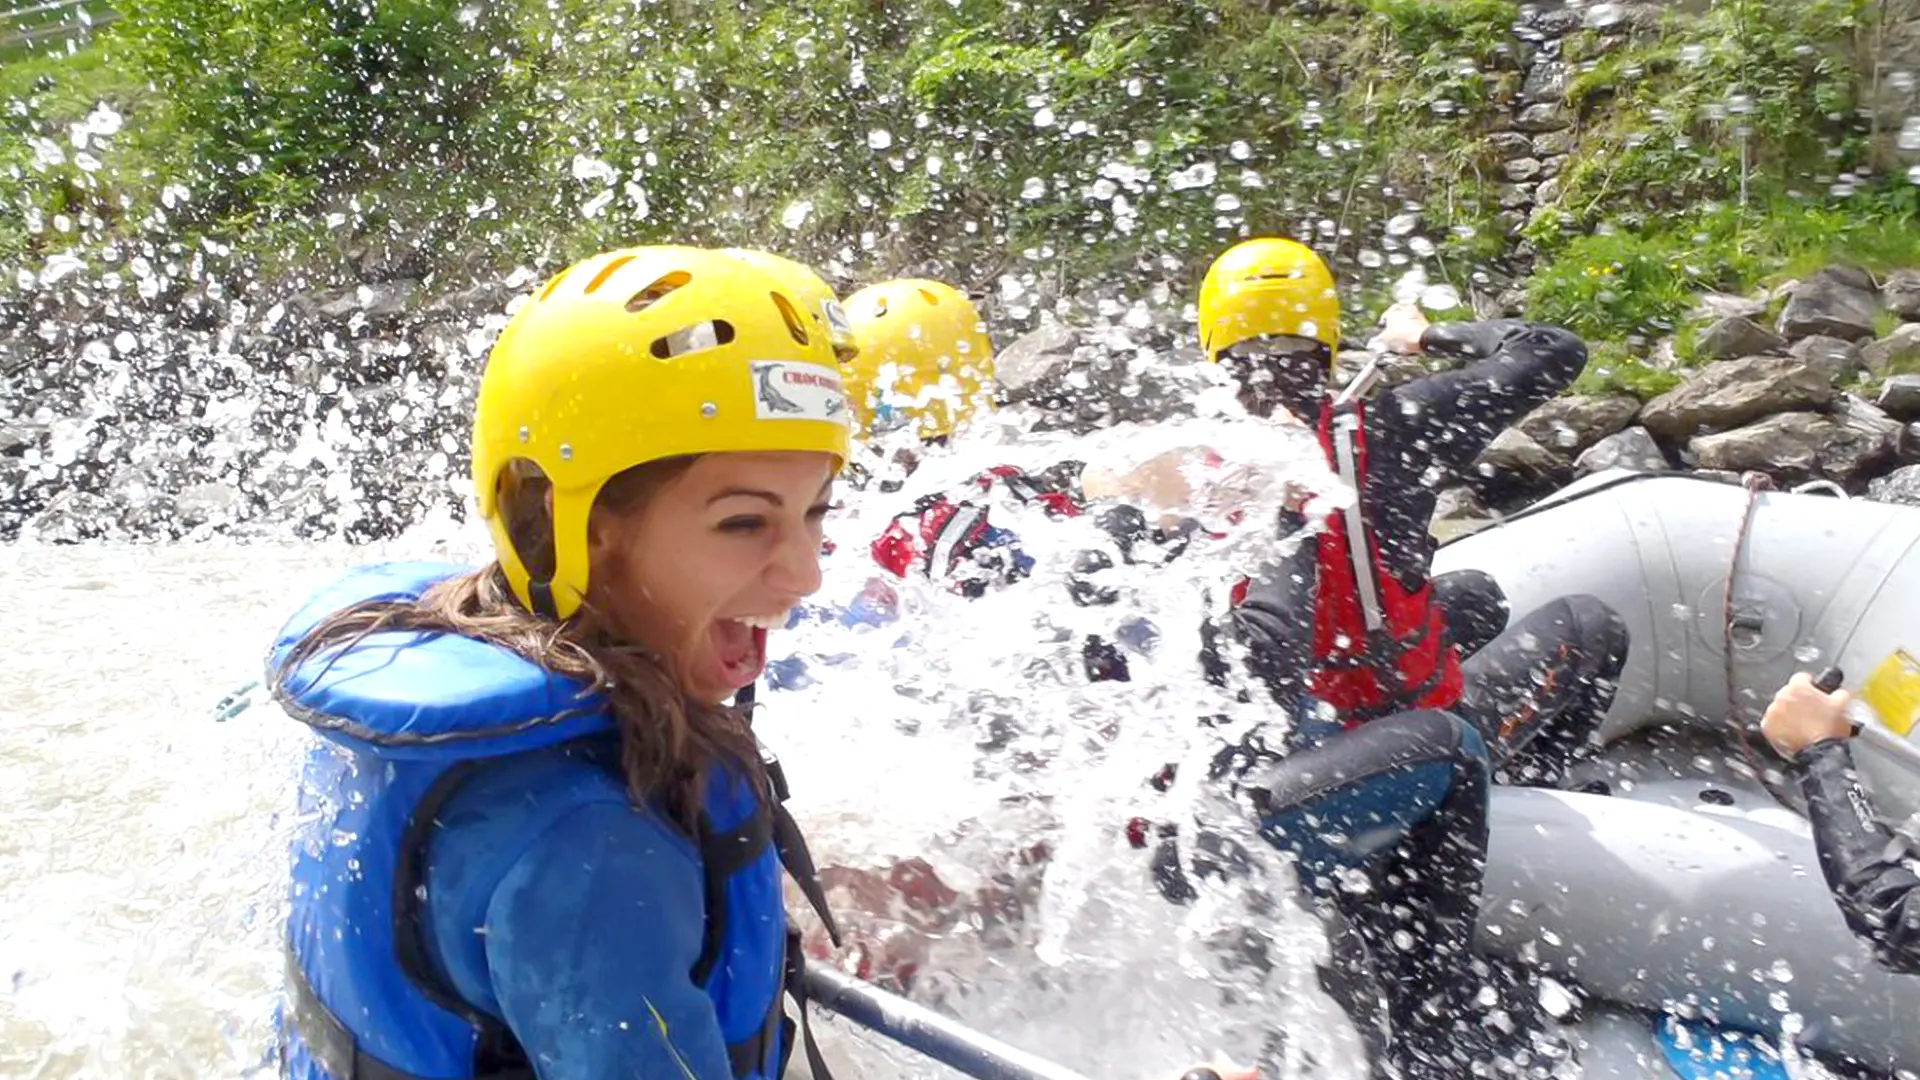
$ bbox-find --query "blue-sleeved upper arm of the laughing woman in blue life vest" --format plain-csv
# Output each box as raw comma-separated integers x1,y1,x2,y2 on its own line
426,787,732,1080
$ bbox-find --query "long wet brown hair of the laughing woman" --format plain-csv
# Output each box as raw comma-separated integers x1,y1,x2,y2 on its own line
275,457,768,832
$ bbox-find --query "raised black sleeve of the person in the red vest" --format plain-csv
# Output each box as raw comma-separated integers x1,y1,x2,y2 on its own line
1369,319,1586,477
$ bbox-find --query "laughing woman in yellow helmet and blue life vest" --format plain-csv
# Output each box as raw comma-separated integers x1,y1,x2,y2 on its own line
271,248,849,1080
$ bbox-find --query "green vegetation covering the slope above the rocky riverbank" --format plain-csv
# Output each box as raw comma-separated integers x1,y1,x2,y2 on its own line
0,0,1920,349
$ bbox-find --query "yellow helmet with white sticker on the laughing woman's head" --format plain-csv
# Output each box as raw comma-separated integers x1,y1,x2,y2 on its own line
472,246,851,619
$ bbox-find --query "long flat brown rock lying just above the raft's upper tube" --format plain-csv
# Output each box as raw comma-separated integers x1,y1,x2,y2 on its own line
1688,402,1901,484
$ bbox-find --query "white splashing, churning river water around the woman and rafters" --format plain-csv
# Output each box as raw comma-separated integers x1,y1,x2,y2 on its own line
0,407,1359,1078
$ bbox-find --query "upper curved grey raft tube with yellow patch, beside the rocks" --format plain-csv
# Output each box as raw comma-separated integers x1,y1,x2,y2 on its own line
1434,471,1920,815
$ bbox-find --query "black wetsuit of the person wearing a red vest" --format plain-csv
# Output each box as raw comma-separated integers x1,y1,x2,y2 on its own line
1154,323,1626,1080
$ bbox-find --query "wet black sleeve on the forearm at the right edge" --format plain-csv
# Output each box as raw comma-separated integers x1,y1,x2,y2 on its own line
1795,740,1920,974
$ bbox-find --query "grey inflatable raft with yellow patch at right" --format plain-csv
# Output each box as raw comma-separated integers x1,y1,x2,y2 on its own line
1434,473,1920,1080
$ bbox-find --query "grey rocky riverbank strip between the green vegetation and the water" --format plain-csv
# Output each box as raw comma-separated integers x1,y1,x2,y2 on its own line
0,255,1920,542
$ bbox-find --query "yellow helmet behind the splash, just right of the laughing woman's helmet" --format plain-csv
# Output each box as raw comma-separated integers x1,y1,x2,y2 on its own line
845,279,993,438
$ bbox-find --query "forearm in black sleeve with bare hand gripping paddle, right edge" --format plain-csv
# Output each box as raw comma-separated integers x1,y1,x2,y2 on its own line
1761,673,1920,972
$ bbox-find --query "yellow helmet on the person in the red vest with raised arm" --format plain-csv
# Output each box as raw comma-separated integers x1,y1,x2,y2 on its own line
1200,236,1340,361
